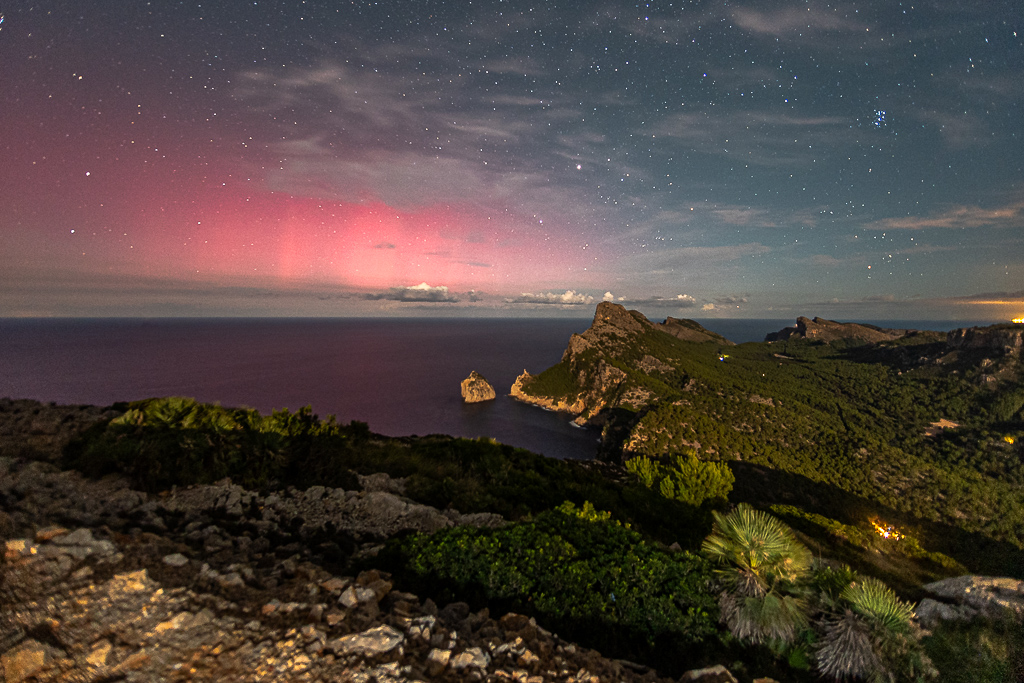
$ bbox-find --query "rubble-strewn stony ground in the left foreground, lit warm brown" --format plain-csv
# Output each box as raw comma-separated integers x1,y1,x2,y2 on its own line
0,401,720,683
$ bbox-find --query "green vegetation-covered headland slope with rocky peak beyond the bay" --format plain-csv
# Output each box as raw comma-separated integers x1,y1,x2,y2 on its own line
513,303,1024,577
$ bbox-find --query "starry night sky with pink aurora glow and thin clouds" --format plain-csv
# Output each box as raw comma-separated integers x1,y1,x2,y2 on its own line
0,0,1024,319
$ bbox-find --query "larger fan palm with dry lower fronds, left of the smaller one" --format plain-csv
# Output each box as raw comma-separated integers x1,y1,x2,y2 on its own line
702,504,811,644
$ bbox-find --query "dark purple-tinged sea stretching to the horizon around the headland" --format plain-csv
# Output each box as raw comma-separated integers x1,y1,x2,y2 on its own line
0,318,1003,459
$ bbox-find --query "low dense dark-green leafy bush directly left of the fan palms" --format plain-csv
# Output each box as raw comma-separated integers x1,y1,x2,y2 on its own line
389,503,717,652
